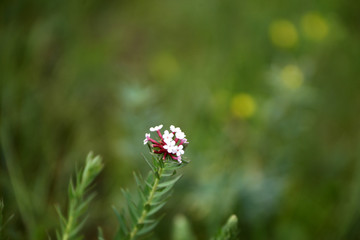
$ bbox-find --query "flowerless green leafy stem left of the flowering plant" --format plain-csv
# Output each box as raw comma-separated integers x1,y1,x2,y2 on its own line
56,153,103,240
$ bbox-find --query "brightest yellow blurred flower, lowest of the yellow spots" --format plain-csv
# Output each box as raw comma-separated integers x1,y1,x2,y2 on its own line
231,93,256,118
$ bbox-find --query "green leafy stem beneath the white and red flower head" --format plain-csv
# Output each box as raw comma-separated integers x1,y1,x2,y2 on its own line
114,156,186,240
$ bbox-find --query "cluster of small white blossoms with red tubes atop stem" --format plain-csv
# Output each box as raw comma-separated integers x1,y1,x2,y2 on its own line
144,125,188,163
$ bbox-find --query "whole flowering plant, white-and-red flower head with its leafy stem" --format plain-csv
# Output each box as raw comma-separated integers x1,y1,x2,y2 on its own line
114,125,188,240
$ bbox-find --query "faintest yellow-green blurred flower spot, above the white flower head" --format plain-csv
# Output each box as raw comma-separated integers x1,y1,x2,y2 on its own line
149,52,179,80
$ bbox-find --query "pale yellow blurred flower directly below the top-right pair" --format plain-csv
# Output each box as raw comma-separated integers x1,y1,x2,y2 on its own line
280,64,304,89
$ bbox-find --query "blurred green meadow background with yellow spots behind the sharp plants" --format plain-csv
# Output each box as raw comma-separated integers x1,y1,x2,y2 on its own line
0,0,360,240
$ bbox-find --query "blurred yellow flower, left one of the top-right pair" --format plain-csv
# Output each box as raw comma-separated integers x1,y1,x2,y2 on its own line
269,20,298,48
